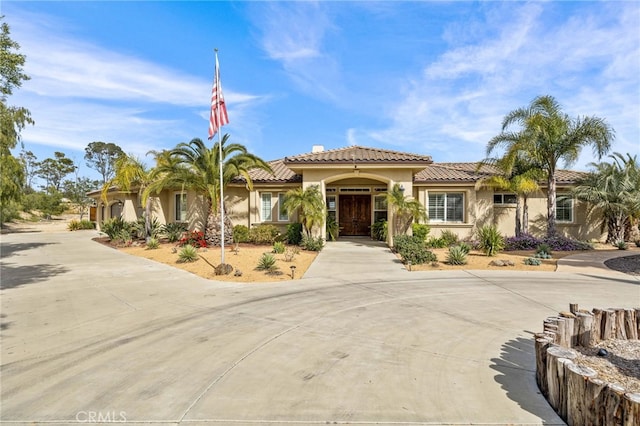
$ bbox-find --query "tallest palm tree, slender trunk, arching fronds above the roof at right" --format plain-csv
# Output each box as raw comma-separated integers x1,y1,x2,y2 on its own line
487,96,614,236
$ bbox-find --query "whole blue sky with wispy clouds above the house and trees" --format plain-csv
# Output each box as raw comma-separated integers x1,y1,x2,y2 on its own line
0,0,640,181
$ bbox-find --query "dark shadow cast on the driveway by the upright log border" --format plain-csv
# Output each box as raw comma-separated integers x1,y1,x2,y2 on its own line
491,337,565,425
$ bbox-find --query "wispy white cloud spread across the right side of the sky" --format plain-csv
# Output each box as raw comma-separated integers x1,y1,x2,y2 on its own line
369,3,640,168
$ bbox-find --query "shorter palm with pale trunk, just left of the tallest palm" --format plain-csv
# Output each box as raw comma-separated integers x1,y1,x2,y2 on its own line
476,155,540,237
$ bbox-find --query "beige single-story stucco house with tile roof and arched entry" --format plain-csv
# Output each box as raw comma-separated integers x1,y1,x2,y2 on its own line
90,145,602,242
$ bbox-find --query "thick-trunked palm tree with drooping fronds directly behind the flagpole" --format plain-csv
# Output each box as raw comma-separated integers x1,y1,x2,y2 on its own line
148,134,272,245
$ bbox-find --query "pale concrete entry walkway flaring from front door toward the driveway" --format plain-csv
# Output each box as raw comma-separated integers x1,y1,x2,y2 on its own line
304,237,408,280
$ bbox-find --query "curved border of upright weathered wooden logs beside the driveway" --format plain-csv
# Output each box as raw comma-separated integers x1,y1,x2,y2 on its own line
535,304,640,426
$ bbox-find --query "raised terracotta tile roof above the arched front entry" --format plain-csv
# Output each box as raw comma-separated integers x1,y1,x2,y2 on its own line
284,145,433,165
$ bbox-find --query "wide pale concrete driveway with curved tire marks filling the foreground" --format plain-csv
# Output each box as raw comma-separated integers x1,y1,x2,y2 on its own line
0,232,640,425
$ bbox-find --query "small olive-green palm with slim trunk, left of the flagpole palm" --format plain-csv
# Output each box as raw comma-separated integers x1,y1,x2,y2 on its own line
102,154,154,241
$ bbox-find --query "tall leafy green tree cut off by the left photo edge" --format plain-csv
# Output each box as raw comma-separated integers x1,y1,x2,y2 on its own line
0,16,33,222
